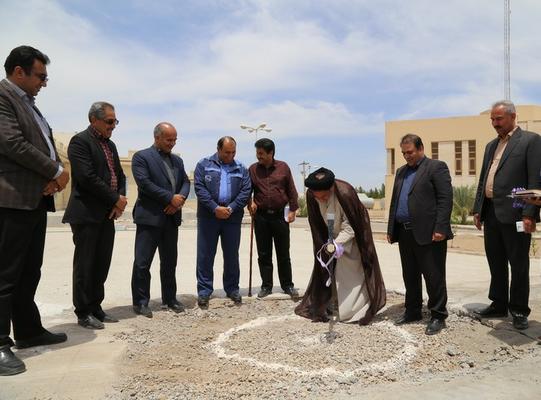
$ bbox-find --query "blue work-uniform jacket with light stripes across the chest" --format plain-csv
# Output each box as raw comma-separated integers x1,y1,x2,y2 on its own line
194,153,252,223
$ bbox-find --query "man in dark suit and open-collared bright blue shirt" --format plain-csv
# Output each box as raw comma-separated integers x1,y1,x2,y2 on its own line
387,134,453,335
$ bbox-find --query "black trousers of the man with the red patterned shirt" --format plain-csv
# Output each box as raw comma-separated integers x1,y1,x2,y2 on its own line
71,219,115,318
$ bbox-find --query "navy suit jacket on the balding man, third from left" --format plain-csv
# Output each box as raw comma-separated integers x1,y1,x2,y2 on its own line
132,146,190,226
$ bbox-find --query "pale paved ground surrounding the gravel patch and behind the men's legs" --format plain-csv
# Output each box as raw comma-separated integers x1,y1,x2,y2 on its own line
0,206,541,400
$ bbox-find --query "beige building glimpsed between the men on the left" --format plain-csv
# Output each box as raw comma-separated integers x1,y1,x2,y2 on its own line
54,133,193,211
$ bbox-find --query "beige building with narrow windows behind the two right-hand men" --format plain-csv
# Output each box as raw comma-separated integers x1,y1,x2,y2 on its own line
385,105,541,209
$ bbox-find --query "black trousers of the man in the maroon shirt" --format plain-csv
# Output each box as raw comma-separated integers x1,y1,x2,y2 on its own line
254,211,293,290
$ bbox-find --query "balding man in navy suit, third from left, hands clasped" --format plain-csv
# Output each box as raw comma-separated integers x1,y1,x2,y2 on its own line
131,122,190,318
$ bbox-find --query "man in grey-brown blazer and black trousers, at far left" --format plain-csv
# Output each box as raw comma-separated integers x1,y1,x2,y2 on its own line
0,46,69,375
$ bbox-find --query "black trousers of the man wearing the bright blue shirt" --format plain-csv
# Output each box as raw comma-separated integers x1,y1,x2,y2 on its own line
398,226,448,319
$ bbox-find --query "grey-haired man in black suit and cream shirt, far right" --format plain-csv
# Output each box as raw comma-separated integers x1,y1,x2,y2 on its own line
473,101,541,329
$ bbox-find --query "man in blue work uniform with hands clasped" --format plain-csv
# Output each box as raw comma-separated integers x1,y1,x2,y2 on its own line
194,136,252,308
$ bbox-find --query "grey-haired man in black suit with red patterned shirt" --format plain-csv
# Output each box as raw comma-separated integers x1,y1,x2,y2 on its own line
62,101,127,329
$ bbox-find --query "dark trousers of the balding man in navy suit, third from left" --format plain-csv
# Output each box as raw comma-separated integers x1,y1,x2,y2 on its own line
131,218,178,305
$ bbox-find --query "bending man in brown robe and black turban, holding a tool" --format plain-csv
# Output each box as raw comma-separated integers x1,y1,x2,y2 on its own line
295,168,386,325
